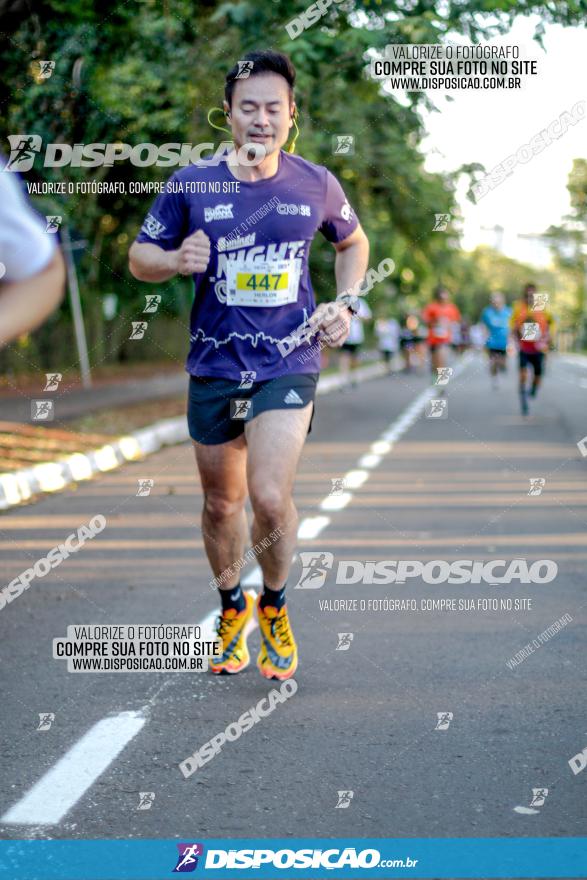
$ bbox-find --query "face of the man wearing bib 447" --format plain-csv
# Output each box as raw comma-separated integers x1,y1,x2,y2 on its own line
224,73,294,155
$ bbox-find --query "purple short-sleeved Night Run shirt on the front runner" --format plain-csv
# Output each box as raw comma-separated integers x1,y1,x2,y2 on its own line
137,151,358,381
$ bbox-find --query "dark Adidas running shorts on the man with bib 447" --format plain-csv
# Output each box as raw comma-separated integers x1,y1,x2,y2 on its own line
188,373,318,445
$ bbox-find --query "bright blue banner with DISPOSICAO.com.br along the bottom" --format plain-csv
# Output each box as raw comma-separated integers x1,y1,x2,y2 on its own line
0,837,587,880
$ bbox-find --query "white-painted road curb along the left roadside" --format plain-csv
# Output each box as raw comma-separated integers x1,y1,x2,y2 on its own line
0,364,396,511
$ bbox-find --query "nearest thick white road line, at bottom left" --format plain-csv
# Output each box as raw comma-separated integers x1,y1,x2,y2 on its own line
0,712,147,825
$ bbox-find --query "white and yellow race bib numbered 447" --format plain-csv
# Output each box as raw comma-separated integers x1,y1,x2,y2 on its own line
226,259,301,308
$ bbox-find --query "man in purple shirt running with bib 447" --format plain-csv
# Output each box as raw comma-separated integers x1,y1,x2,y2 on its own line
129,51,369,680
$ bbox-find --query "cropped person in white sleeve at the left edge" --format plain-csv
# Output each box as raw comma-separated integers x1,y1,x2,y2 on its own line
0,162,65,348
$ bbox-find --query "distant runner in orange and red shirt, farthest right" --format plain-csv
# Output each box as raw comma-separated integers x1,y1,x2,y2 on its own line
510,284,554,416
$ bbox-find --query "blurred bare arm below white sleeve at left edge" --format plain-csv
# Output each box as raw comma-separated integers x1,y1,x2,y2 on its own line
0,250,65,348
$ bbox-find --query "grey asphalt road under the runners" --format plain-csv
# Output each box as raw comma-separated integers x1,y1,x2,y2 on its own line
0,357,587,852
